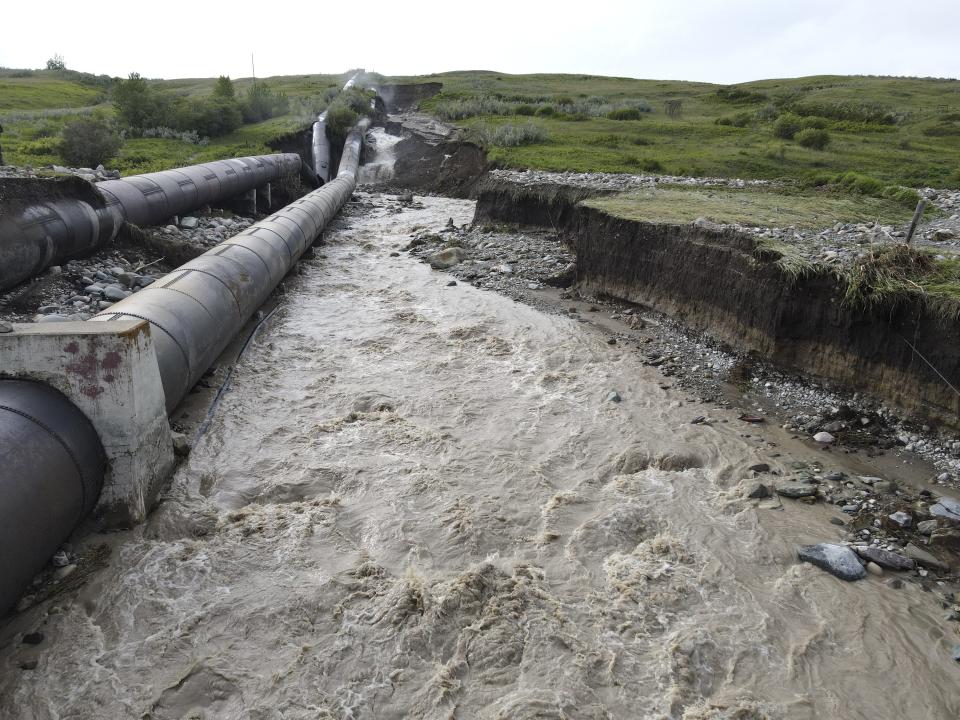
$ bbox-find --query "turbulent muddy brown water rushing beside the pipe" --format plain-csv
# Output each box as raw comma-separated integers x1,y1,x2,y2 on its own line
0,193,960,720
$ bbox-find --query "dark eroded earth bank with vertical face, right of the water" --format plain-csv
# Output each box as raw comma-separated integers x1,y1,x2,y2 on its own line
476,182,960,427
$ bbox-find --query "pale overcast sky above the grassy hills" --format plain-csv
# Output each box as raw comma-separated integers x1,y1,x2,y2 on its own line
0,0,960,83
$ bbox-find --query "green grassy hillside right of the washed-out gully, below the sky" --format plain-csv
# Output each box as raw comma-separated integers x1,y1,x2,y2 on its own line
391,71,960,187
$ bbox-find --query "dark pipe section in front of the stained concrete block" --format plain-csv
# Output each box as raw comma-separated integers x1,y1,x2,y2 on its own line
0,380,106,614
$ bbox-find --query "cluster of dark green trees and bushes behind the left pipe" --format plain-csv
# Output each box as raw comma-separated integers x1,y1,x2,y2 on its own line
113,73,290,137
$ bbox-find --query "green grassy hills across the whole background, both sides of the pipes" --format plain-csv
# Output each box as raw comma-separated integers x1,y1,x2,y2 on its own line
0,69,960,187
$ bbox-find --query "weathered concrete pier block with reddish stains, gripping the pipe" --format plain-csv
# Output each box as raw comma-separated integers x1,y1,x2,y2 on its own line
0,318,175,527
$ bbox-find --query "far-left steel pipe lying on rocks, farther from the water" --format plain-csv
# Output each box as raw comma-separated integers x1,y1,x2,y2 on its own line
0,153,301,290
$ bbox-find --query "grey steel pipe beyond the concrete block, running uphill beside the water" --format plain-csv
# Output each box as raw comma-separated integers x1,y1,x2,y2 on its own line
91,125,365,412
